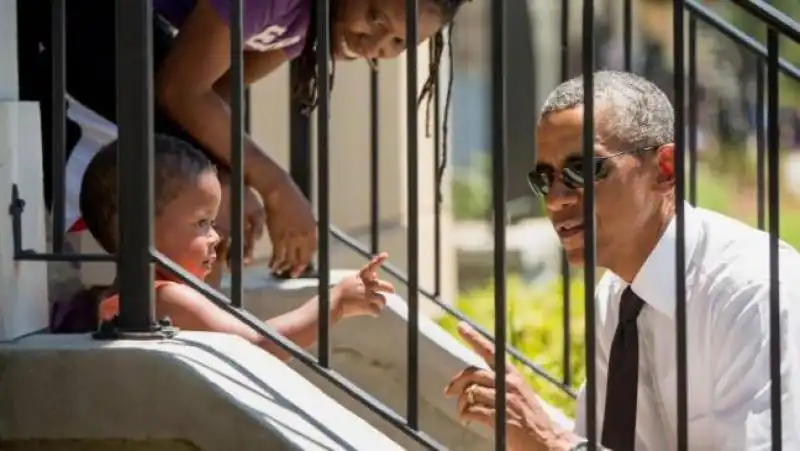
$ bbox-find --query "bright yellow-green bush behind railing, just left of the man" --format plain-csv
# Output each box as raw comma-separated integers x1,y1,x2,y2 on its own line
440,276,585,416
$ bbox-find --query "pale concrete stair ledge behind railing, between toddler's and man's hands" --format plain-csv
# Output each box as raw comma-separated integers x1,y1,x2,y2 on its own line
223,266,572,451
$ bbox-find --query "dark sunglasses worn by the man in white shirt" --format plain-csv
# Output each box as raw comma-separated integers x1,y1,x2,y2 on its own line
528,146,661,197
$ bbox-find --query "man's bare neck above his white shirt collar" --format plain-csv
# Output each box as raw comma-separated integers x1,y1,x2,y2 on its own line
608,201,675,283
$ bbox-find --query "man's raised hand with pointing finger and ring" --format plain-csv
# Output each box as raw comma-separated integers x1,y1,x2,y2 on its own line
445,323,574,451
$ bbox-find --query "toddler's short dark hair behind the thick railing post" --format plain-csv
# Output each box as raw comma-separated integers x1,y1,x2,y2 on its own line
80,135,216,254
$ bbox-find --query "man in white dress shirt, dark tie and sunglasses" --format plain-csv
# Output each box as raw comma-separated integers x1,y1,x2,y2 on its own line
446,71,800,451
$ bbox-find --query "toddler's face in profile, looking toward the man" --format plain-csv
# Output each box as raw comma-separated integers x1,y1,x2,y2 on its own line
155,171,222,279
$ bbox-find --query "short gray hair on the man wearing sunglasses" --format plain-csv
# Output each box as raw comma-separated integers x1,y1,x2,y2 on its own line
539,70,675,150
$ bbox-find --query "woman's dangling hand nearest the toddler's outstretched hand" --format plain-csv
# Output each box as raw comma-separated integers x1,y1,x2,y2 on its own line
262,176,317,277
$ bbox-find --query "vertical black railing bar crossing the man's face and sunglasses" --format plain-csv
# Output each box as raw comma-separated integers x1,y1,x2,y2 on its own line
581,0,597,451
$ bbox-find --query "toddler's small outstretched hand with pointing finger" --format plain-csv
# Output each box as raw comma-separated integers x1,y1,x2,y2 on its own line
331,252,394,319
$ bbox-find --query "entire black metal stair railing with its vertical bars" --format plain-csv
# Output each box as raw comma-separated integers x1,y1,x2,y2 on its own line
10,0,800,450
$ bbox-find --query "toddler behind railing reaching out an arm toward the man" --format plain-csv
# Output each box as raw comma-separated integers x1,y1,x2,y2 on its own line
53,135,393,359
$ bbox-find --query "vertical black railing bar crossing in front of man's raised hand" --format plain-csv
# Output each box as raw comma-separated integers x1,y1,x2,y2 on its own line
490,0,507,451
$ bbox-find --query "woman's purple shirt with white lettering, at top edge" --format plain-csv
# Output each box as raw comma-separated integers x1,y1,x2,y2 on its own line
153,0,313,59
